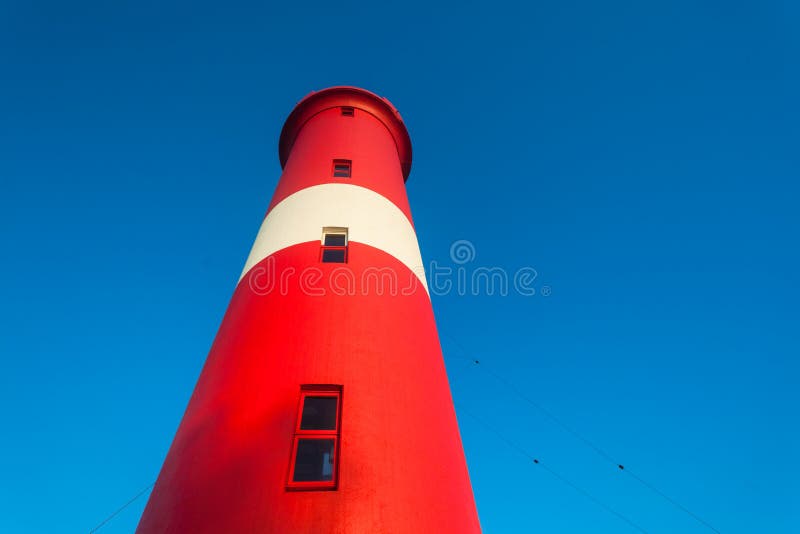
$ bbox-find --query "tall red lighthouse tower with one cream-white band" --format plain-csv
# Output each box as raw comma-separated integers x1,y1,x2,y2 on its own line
137,87,480,534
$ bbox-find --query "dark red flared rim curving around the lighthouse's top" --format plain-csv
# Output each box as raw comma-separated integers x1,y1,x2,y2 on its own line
278,86,411,179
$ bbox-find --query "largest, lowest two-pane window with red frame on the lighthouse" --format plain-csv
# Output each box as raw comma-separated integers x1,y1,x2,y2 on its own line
287,385,342,490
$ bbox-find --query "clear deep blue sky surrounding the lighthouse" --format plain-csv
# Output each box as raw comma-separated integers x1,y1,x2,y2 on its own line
0,0,800,533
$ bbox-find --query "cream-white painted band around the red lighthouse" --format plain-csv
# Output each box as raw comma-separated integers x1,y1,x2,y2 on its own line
239,184,428,292
